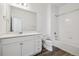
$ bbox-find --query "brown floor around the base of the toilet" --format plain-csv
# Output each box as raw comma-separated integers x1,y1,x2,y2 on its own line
36,47,73,56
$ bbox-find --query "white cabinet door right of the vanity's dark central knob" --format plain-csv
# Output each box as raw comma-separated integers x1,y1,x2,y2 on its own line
22,38,35,56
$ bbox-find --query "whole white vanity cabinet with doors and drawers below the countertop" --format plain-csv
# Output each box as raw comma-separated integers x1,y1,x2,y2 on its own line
0,35,42,56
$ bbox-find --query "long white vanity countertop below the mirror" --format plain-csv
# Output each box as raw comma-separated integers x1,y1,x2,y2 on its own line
0,32,40,39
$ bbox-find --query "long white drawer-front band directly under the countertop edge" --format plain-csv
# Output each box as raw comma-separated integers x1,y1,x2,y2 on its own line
1,35,39,44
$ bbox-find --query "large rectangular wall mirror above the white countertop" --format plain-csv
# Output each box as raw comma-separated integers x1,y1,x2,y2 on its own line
11,6,37,32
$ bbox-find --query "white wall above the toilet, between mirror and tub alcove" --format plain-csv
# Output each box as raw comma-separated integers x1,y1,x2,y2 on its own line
30,3,50,34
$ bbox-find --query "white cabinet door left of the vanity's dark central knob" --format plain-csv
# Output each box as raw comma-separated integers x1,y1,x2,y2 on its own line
2,43,21,56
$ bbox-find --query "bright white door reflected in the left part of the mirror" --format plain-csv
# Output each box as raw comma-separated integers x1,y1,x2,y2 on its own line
12,16,22,33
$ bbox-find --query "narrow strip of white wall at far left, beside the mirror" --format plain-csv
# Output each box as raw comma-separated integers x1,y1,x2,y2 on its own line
0,3,6,35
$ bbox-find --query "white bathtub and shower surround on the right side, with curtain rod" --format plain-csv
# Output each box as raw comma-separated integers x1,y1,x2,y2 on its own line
52,3,79,55
